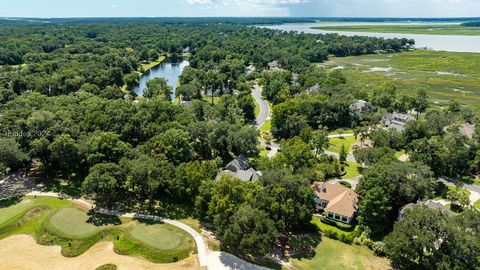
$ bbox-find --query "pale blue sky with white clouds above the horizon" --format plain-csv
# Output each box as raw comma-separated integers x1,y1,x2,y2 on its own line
0,0,480,18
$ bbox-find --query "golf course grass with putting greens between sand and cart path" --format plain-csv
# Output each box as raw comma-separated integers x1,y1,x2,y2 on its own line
0,197,195,263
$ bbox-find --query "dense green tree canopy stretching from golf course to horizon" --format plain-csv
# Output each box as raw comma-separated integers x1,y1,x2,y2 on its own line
0,19,480,269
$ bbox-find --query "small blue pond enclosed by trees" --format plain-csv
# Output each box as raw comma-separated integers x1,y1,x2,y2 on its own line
133,59,190,99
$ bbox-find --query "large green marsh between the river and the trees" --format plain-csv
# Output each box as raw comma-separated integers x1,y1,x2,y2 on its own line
322,50,480,109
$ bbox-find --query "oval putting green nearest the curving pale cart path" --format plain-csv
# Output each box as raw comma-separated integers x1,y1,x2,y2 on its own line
130,224,193,250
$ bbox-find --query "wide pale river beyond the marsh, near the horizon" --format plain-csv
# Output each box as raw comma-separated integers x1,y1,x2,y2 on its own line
260,23,480,53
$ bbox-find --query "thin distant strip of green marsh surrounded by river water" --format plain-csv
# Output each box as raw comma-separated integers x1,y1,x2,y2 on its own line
313,24,480,36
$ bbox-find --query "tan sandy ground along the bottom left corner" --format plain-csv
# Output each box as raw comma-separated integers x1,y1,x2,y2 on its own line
0,235,199,270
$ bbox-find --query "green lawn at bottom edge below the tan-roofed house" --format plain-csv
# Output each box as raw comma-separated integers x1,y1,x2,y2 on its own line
285,237,391,270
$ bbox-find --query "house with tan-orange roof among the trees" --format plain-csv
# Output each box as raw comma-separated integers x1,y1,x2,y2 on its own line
313,182,360,223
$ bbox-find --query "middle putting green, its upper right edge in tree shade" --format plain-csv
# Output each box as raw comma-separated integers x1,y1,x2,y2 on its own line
48,208,103,239
